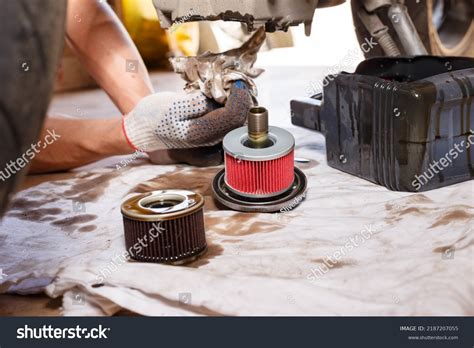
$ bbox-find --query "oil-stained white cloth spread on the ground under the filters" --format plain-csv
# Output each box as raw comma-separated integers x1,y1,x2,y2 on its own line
0,123,474,316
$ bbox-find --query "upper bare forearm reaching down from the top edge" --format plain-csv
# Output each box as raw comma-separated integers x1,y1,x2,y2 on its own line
66,0,153,114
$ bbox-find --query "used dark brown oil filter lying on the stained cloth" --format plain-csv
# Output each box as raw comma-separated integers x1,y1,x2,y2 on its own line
121,190,207,265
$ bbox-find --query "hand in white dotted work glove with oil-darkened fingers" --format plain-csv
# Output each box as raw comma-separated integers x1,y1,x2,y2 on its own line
123,81,253,152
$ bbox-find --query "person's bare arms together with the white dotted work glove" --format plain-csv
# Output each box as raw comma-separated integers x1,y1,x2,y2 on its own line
30,0,252,173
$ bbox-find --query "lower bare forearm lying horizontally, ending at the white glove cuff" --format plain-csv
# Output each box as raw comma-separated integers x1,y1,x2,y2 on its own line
30,117,134,173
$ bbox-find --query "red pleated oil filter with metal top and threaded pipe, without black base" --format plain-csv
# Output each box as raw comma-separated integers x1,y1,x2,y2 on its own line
223,107,295,198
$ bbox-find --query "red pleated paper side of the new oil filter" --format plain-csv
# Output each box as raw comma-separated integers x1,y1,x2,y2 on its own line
225,149,295,196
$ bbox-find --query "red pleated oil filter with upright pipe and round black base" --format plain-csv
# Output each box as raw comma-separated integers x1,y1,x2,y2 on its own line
212,106,307,212
